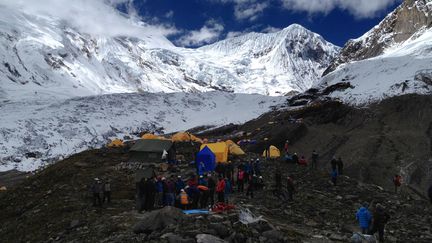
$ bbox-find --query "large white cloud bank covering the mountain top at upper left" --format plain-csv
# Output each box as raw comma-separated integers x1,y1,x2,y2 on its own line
0,0,178,37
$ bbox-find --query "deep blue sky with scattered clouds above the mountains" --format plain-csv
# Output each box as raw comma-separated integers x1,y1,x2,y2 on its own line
120,0,401,47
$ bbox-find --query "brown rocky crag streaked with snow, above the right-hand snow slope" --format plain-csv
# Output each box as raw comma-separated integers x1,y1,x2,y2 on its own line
323,0,432,76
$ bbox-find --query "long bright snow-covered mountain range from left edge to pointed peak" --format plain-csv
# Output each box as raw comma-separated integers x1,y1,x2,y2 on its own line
0,3,338,100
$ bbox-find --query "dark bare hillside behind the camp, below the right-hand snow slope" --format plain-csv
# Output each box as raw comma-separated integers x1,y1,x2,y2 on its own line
204,95,432,198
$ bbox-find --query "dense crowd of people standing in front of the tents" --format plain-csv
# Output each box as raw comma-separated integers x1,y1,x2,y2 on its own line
136,159,272,212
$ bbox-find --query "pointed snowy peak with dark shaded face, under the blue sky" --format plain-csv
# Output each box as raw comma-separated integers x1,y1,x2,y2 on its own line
199,24,339,95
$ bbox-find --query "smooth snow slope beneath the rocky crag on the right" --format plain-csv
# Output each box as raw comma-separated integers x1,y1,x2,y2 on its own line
318,29,432,105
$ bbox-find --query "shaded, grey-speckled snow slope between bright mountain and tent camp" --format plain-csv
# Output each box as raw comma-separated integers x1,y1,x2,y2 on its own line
0,92,286,171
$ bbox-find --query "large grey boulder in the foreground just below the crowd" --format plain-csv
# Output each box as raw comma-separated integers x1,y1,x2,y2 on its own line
133,207,187,234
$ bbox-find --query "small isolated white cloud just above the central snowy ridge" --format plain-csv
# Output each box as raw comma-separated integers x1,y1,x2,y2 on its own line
176,19,224,46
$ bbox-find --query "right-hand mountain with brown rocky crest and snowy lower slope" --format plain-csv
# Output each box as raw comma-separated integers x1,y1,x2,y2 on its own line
317,0,432,105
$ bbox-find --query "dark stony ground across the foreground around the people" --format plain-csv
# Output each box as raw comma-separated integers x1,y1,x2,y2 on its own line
0,143,432,242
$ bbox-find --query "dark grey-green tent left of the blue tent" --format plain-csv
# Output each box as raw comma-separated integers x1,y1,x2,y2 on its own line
129,139,175,163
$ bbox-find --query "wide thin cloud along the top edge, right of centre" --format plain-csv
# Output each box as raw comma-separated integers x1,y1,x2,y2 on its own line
281,0,401,19
